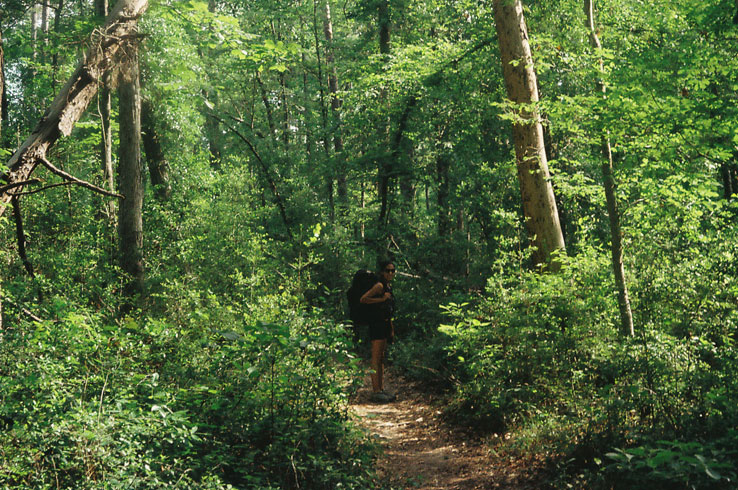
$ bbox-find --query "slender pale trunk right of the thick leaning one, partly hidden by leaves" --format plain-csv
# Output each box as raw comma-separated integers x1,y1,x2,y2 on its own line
584,0,634,337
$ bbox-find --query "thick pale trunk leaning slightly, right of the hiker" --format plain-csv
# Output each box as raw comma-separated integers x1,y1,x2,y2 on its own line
493,0,566,272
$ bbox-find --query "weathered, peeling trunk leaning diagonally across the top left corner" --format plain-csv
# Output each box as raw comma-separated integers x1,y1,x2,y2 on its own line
0,0,148,216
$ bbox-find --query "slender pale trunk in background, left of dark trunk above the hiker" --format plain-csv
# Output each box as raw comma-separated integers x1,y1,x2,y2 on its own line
323,0,348,206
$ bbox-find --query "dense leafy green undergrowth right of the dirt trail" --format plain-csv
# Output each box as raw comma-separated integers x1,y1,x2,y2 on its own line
396,201,738,489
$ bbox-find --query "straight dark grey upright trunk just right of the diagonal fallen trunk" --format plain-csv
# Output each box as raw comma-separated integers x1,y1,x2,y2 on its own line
118,46,144,296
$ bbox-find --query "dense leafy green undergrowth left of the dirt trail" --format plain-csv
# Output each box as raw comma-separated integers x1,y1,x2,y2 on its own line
0,167,376,490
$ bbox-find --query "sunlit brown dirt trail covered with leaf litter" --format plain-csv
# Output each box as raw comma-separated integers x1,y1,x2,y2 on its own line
352,370,545,490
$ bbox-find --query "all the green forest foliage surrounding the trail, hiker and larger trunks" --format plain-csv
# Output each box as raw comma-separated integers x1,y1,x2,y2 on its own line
0,0,738,489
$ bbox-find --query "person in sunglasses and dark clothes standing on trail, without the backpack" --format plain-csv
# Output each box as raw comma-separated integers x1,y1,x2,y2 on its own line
360,260,396,403
